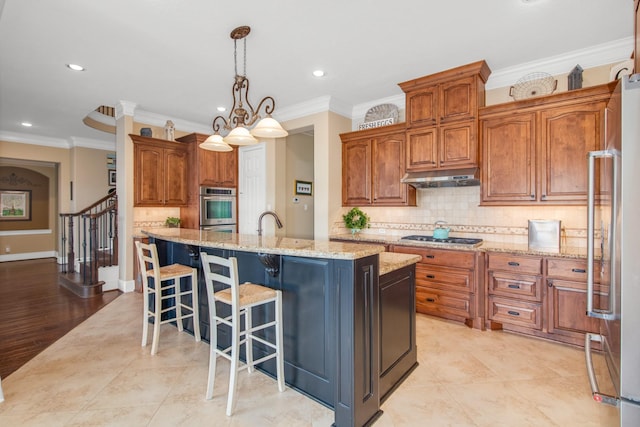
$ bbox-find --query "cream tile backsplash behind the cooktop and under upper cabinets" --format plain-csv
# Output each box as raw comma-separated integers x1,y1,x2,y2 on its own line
338,187,587,247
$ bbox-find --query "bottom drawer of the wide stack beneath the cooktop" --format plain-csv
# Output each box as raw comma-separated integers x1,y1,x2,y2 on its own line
416,286,472,320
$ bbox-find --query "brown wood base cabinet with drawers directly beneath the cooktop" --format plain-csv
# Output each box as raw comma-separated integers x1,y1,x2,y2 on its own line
392,245,484,329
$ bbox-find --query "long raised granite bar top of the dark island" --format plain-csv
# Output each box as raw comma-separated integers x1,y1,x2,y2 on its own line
141,228,384,259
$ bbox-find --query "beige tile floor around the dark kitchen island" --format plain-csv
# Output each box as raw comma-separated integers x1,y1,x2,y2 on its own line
0,293,617,427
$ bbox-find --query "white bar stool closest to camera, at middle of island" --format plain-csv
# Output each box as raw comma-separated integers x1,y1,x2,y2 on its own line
200,252,285,416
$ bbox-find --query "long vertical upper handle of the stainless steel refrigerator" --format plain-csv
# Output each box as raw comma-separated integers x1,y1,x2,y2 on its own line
587,150,618,320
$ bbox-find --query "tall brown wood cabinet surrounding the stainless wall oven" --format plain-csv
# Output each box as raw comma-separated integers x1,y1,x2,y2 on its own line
177,133,238,228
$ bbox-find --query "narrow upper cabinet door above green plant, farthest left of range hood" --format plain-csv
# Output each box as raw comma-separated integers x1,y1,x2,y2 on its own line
342,139,372,206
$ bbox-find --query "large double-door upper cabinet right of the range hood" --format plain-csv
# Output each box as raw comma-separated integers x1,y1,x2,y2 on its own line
480,84,614,205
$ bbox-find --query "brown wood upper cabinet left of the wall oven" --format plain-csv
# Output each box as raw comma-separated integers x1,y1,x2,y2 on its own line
129,135,189,206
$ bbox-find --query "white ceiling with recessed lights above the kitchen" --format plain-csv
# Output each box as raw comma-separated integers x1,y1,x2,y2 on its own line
0,0,633,150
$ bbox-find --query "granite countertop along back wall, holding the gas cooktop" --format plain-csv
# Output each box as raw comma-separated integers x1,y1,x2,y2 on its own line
331,233,598,259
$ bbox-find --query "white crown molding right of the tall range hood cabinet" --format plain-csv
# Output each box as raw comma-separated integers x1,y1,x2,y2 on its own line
485,37,633,89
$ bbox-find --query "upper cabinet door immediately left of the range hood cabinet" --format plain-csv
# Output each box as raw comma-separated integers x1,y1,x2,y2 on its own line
372,132,407,205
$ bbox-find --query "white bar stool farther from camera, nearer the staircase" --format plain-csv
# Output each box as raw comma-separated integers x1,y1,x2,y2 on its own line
135,242,200,354
